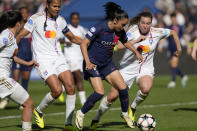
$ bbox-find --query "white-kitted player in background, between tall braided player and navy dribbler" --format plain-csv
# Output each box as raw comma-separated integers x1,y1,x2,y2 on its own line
59,12,87,105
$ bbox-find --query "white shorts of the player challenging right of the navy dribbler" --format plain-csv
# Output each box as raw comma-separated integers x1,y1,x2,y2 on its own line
119,65,154,88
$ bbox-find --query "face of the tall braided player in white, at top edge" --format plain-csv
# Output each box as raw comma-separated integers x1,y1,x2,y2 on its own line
47,0,61,17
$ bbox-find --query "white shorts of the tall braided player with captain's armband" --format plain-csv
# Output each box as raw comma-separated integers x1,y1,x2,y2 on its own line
36,56,70,80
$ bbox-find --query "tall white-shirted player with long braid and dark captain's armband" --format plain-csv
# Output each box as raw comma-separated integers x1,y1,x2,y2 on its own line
16,0,81,128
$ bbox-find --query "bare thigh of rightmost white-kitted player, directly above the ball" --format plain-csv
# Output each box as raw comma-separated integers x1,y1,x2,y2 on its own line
137,75,153,94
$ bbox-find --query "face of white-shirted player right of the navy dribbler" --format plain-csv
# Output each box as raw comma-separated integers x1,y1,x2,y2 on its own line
138,16,152,34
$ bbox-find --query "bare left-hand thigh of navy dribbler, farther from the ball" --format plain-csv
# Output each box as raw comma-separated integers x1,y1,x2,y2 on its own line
89,77,104,95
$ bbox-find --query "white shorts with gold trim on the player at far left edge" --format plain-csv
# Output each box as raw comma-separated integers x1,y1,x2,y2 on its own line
0,78,29,105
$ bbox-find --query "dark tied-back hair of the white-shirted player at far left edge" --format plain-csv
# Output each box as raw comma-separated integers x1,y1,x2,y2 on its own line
0,11,22,33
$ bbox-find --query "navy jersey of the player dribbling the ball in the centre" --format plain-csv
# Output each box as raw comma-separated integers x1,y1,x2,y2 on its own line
86,21,127,66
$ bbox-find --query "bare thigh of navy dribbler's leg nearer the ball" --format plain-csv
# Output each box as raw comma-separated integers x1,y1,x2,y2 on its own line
105,70,126,90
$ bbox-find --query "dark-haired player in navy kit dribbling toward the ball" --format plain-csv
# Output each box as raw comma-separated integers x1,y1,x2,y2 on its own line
75,2,144,129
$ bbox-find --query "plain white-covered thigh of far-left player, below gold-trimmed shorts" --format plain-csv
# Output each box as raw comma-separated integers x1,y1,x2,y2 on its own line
9,80,29,105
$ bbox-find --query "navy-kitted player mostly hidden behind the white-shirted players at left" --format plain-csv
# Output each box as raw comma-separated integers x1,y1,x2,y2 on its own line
12,7,32,90
